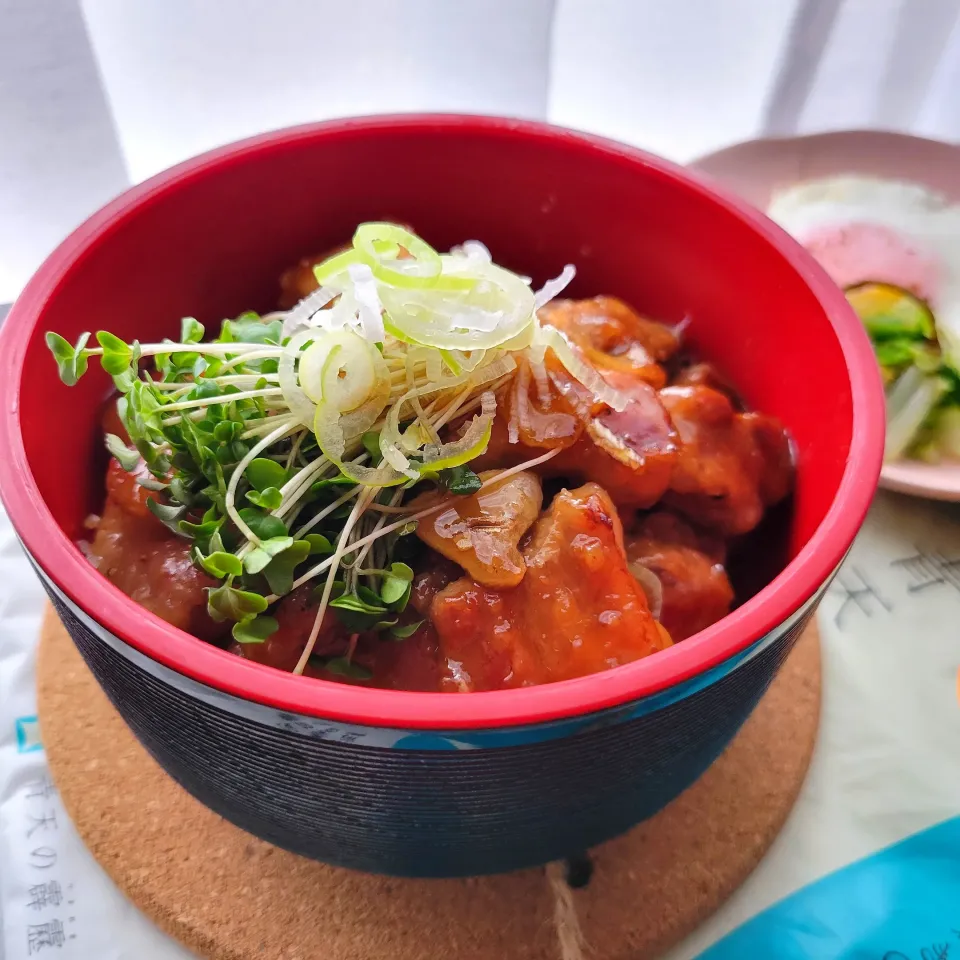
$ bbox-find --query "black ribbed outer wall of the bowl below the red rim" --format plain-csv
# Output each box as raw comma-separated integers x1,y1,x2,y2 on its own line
35,571,822,877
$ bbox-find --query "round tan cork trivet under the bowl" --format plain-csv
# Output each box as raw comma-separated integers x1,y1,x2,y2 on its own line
38,611,820,960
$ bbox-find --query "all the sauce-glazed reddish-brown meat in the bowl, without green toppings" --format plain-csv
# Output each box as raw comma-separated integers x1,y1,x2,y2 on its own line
89,266,793,692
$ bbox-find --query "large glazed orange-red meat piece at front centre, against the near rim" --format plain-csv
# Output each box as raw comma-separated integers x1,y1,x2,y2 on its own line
431,483,670,691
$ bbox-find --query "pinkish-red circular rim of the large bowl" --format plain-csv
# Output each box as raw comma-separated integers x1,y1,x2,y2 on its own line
0,114,884,730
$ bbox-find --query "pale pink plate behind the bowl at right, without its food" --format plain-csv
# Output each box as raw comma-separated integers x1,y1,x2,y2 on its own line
691,130,960,501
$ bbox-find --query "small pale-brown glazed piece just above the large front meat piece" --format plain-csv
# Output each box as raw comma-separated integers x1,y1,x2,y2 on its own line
410,470,543,587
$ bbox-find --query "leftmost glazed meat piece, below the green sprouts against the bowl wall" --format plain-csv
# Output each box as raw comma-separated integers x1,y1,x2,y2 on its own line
89,461,229,640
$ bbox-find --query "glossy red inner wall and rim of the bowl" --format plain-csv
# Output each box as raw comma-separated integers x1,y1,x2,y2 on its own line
0,117,883,729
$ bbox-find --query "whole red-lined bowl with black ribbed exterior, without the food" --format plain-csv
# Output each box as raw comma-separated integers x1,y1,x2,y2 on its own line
0,116,884,876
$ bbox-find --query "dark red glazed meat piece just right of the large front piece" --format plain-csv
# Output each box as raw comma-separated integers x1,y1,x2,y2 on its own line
626,510,733,642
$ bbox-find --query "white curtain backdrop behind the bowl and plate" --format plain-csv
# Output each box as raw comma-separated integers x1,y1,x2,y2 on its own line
0,0,960,302
